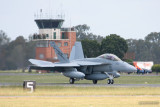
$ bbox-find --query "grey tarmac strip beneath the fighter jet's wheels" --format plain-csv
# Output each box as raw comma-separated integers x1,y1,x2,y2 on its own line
0,83,160,87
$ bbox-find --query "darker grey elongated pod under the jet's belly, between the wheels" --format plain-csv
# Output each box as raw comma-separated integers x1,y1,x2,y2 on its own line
84,73,108,80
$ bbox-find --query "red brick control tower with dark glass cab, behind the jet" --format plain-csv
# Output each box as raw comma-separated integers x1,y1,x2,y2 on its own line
32,19,76,62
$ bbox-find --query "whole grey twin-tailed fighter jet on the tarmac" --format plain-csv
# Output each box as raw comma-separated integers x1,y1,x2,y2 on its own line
29,42,137,84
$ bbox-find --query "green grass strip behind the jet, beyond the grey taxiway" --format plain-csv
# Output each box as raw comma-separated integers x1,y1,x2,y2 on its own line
0,73,160,84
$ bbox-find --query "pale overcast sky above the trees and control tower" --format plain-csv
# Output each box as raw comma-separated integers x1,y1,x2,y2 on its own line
0,0,160,39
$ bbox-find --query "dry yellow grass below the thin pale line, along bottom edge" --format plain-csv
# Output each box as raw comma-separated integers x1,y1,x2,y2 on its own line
0,96,160,107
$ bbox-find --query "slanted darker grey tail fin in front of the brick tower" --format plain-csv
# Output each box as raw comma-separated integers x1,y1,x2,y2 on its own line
50,42,69,63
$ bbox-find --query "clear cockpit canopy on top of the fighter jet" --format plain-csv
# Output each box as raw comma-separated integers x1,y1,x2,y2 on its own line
98,54,121,61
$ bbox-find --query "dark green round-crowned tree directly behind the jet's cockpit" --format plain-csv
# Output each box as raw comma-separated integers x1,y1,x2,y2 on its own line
101,34,128,59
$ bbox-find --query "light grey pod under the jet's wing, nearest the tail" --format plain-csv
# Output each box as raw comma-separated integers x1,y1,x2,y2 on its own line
63,68,85,79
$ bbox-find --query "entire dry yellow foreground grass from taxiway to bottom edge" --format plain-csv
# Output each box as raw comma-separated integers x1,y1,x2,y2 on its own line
0,86,160,107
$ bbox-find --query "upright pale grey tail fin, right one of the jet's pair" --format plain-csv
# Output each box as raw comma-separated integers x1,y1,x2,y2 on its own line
69,42,84,61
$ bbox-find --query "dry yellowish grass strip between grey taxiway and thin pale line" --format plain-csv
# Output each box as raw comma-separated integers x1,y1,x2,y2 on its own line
0,86,160,96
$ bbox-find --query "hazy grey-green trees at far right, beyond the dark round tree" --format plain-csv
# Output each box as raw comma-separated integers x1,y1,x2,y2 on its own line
127,32,160,64
